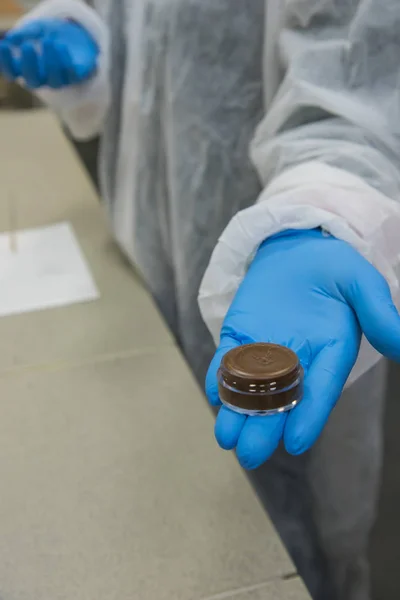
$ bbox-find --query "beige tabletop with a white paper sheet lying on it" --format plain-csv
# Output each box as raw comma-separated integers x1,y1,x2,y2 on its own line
0,113,307,600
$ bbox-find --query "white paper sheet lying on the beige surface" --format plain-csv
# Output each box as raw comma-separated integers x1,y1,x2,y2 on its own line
0,223,99,317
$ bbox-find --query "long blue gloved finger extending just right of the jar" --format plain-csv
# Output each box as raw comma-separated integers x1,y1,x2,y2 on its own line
284,339,358,454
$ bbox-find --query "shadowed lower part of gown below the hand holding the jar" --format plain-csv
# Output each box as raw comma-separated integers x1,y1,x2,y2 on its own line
250,361,386,600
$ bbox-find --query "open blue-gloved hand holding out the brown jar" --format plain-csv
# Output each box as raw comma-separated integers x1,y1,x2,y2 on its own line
206,230,400,469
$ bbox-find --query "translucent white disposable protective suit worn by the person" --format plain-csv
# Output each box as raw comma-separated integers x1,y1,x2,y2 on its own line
19,0,400,600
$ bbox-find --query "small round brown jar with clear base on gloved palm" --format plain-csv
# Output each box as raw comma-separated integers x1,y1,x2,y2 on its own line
218,343,303,415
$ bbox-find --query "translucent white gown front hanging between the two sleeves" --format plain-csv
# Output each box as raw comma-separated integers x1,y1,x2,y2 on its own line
100,0,264,381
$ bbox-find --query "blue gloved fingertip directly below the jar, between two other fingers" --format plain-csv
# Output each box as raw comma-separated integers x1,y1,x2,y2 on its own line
236,413,287,470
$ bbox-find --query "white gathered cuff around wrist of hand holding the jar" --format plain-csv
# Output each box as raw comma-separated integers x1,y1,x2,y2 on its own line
199,162,400,380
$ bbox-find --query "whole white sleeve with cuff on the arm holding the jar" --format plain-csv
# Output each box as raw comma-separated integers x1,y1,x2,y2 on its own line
199,0,400,370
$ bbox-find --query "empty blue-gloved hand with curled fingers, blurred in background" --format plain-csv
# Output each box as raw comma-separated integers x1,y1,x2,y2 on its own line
0,19,99,90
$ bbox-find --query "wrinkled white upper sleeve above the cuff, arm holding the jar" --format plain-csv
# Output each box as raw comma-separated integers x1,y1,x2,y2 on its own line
252,0,400,199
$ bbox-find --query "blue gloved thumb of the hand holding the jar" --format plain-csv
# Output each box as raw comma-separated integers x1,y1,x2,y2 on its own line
342,259,400,362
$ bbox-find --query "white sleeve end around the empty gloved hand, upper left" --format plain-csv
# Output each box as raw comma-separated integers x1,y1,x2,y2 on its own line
17,0,110,140
